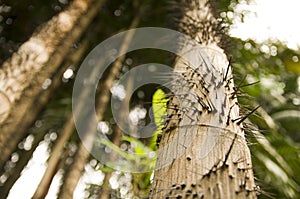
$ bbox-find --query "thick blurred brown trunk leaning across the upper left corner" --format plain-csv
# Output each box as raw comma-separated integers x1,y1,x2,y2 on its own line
0,0,103,169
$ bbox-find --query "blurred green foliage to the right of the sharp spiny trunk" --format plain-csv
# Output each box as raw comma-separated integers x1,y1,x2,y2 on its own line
230,38,300,198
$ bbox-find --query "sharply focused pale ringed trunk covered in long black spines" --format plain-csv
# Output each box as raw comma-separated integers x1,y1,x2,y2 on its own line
150,0,256,199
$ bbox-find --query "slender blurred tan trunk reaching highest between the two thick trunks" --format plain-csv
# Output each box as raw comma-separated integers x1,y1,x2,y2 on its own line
59,15,140,199
